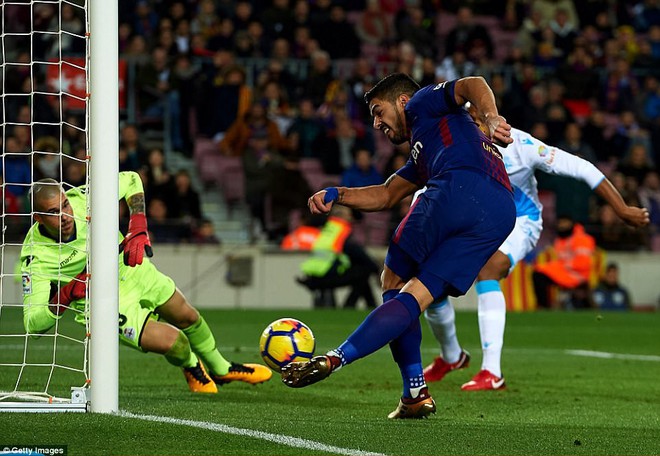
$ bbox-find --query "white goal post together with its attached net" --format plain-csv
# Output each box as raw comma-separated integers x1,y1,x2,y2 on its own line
0,0,119,413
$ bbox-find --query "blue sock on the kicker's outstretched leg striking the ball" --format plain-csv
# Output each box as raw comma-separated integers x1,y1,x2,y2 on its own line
339,293,421,366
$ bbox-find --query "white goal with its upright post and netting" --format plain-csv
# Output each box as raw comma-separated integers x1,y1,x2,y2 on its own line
0,0,119,413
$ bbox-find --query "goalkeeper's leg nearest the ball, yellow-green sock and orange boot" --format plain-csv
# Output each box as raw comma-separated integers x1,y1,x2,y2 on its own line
156,289,272,385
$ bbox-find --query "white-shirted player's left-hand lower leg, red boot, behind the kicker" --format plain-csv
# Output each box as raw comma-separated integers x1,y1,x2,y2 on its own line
424,298,470,382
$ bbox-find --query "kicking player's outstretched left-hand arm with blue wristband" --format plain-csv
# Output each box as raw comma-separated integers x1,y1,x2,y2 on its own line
308,174,419,214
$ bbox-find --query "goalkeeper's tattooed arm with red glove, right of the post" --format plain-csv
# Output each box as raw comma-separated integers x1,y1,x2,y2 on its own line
119,171,153,266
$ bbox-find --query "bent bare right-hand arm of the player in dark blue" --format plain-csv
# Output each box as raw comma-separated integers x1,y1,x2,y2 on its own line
454,76,513,147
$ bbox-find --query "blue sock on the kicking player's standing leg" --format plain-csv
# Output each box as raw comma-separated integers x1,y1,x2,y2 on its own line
390,319,426,398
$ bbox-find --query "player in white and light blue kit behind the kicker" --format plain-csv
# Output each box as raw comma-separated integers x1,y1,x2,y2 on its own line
424,117,649,391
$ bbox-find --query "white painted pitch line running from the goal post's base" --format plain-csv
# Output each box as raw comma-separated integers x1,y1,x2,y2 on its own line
117,411,385,456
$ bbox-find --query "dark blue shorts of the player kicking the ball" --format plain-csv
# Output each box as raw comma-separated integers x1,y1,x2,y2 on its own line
385,170,516,298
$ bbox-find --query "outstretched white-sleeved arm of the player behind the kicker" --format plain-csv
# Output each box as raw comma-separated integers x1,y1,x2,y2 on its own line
529,147,649,227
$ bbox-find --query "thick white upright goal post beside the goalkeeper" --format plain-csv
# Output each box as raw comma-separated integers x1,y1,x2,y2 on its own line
88,0,119,413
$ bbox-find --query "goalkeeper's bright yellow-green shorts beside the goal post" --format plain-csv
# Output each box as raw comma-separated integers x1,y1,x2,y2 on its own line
119,258,176,350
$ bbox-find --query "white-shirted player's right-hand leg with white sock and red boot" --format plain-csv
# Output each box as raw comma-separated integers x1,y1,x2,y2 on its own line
461,250,513,391
